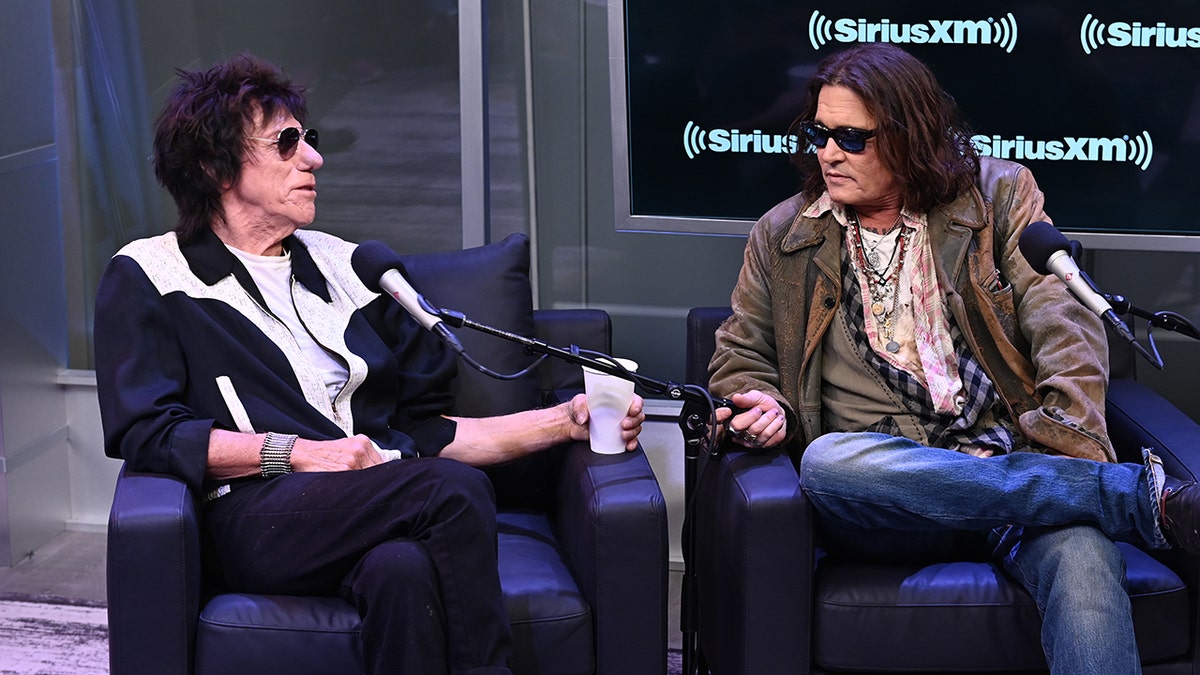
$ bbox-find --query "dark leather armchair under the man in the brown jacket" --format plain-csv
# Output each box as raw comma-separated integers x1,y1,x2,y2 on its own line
688,307,1200,675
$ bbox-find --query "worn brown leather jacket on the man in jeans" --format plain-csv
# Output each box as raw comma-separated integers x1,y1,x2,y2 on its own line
709,157,1116,461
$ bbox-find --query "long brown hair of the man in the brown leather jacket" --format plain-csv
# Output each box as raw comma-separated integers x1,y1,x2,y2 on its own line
792,42,979,213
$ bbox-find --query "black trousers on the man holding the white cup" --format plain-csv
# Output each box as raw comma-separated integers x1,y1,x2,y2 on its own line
204,458,511,675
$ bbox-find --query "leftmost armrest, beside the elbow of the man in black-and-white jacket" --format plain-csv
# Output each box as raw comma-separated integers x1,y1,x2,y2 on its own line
107,467,200,675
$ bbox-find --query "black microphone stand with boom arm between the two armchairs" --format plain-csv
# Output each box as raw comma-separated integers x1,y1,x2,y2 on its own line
439,305,724,675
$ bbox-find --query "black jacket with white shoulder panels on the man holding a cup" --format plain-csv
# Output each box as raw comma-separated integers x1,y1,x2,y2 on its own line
95,225,456,488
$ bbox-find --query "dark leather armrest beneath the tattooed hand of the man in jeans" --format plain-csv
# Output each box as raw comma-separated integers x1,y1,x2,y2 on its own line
689,452,814,675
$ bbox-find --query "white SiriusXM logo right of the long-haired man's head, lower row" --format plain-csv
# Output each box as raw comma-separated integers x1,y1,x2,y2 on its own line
971,131,1154,171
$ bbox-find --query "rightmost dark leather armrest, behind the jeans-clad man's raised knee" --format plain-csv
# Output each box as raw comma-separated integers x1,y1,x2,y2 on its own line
1105,380,1200,480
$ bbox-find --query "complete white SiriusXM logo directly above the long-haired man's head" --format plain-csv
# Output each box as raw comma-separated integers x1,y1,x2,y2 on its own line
809,11,1016,53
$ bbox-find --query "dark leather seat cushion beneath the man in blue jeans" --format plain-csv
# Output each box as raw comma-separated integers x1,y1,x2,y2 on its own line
812,544,1190,671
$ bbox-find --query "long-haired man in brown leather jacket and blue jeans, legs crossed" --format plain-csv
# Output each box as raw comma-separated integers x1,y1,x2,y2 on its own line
709,43,1200,673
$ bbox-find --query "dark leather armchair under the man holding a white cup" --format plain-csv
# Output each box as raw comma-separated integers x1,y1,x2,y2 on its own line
108,235,667,675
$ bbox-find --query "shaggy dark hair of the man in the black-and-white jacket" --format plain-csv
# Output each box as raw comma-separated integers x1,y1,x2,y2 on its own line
154,54,307,241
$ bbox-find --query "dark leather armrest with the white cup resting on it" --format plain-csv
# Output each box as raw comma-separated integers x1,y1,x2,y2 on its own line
554,443,668,675
